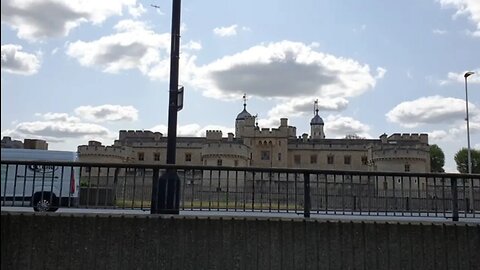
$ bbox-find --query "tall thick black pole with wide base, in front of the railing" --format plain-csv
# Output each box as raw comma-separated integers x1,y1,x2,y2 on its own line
150,0,181,214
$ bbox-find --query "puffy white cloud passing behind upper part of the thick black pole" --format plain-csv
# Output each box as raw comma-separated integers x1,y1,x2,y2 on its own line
67,20,201,81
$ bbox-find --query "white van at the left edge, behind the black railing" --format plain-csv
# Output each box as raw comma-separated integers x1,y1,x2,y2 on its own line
0,148,80,211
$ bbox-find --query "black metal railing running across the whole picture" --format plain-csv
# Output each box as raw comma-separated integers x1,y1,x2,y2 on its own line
1,160,480,220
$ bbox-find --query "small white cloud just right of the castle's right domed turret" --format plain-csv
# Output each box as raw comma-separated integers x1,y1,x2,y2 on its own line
325,115,371,138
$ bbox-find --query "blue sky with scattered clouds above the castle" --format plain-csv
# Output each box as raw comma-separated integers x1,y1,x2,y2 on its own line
1,0,480,172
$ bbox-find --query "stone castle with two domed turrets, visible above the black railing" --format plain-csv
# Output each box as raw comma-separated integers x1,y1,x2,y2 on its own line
78,101,430,173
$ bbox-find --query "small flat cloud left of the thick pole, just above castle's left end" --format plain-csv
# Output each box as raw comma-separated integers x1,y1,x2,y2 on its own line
75,104,138,122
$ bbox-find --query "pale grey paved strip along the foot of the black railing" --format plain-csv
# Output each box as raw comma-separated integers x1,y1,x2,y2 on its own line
1,207,480,224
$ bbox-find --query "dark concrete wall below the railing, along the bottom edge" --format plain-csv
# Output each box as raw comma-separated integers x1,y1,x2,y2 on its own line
1,212,480,270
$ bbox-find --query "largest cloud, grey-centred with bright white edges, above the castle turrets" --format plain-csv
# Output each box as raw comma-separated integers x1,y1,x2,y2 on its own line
191,41,386,99
